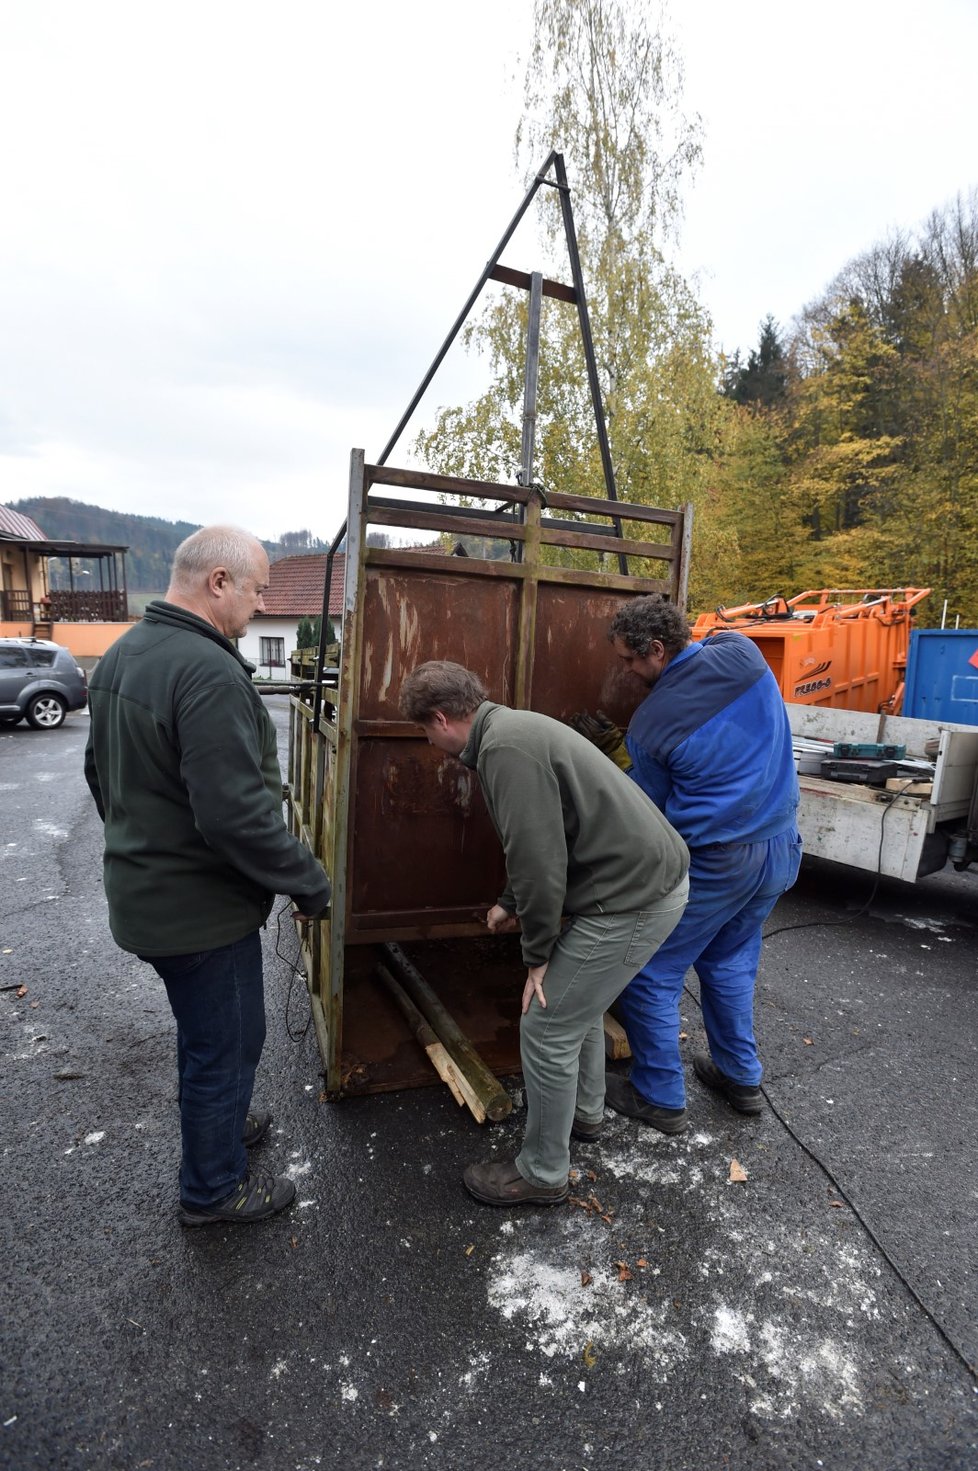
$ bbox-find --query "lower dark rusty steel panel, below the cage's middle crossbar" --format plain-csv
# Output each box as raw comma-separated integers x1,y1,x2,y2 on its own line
350,737,504,925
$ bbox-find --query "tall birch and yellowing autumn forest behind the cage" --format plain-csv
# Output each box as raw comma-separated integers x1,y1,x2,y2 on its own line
416,24,978,624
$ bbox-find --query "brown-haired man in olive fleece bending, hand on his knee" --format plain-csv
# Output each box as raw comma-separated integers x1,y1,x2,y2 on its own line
400,660,690,1205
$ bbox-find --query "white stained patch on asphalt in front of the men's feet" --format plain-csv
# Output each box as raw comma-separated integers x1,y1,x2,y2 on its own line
487,1131,879,1421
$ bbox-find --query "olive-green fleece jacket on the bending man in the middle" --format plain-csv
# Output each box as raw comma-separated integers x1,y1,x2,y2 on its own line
460,700,690,965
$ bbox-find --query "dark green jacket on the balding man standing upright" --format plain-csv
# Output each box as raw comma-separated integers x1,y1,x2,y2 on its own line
85,602,329,956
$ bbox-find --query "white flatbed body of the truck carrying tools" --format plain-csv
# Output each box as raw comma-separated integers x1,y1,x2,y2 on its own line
787,705,978,883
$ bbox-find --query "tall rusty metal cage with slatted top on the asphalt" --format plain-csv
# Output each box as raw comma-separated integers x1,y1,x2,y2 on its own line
288,450,691,1099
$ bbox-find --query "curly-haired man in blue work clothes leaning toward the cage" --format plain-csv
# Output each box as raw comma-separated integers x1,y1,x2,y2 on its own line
575,597,802,1134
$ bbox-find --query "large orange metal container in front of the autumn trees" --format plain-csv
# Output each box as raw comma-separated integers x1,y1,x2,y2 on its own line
693,587,931,715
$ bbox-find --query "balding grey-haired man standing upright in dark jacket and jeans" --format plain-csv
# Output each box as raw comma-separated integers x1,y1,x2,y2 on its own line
85,527,329,1225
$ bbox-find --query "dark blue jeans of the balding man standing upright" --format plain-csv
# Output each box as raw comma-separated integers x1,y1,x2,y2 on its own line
143,930,265,1206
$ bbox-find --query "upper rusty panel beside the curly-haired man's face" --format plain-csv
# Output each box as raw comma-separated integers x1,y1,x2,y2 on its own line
529,583,646,725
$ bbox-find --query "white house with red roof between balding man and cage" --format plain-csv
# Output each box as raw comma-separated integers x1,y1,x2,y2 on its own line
238,552,346,680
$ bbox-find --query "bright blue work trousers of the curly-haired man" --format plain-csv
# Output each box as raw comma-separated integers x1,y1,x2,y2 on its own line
618,830,802,1108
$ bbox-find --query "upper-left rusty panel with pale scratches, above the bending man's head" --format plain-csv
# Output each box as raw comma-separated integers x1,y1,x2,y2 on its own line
357,558,519,721
